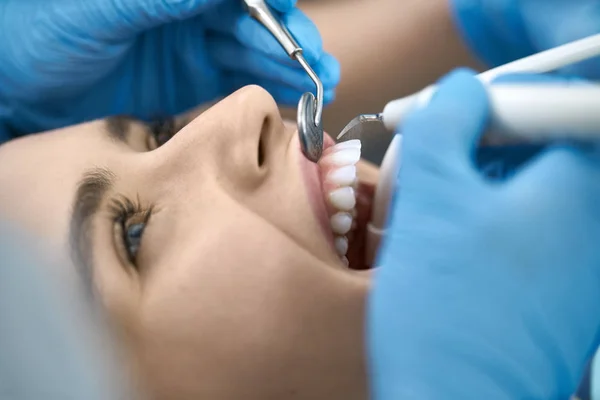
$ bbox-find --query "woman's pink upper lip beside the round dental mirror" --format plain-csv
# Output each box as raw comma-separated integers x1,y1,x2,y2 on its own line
296,134,335,246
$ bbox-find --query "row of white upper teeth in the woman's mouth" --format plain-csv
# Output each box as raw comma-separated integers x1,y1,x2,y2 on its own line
319,139,361,263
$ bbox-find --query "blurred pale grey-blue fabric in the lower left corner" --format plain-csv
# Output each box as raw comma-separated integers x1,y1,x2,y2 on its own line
0,221,130,400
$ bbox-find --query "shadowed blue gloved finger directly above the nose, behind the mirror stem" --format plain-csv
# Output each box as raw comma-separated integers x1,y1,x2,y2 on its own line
225,74,335,107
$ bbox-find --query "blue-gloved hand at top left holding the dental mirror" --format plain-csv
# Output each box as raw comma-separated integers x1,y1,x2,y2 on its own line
0,0,340,139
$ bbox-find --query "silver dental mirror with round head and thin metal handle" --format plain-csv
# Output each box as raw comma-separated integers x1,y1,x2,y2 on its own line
244,0,323,163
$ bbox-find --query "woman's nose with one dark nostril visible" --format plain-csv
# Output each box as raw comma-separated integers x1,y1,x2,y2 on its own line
159,86,289,188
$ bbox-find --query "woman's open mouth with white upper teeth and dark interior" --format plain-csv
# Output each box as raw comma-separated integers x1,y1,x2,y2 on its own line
319,140,375,270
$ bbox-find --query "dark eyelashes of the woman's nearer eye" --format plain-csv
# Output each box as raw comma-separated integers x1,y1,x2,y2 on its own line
110,196,152,269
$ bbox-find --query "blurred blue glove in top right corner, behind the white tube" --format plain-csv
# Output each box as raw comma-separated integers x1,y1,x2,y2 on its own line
450,0,600,79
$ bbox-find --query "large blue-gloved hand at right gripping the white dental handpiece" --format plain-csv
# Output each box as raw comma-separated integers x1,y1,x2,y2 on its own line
368,71,600,400
